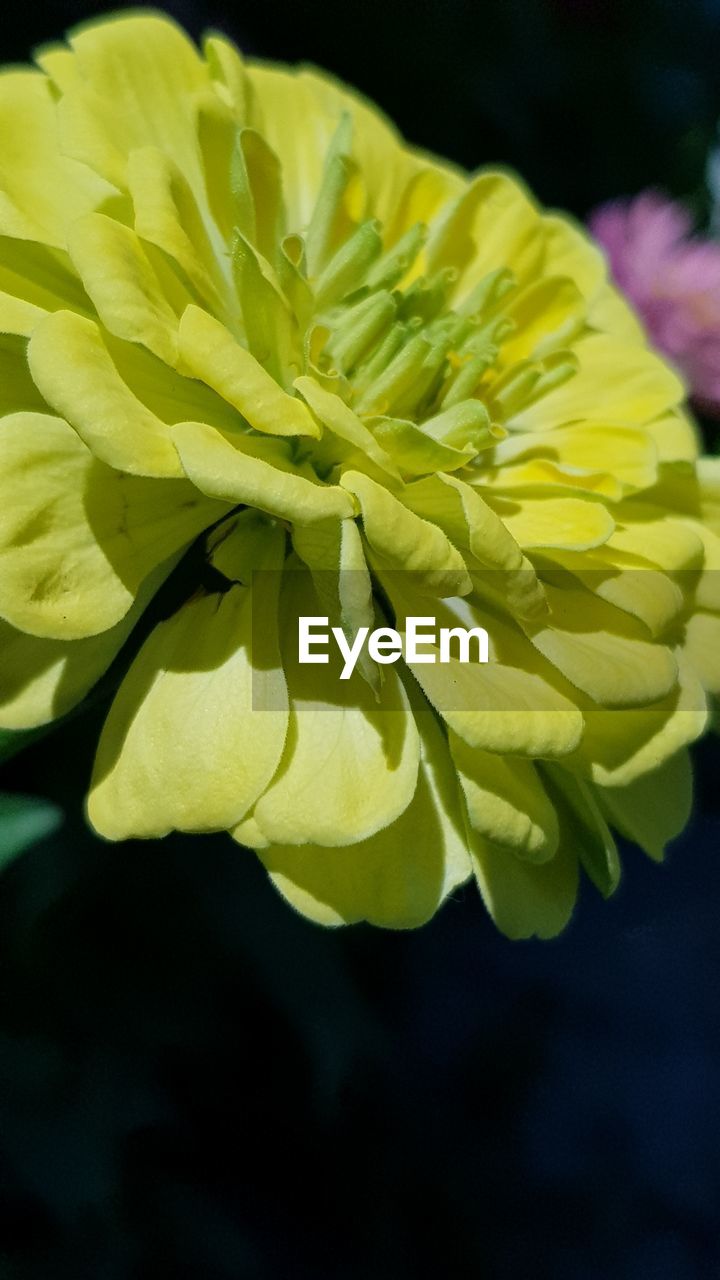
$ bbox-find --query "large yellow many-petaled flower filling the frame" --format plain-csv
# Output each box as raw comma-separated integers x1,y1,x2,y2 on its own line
0,15,720,937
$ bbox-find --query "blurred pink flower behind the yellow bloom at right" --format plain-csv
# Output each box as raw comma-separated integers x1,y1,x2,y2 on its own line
589,191,720,413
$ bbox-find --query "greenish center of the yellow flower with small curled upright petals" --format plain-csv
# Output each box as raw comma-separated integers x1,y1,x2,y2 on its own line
225,118,577,477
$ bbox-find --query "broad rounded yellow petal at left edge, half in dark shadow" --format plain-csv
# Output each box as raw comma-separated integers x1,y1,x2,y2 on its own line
0,413,224,640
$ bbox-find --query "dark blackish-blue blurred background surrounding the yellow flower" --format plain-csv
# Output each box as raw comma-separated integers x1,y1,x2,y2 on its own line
0,0,720,1280
